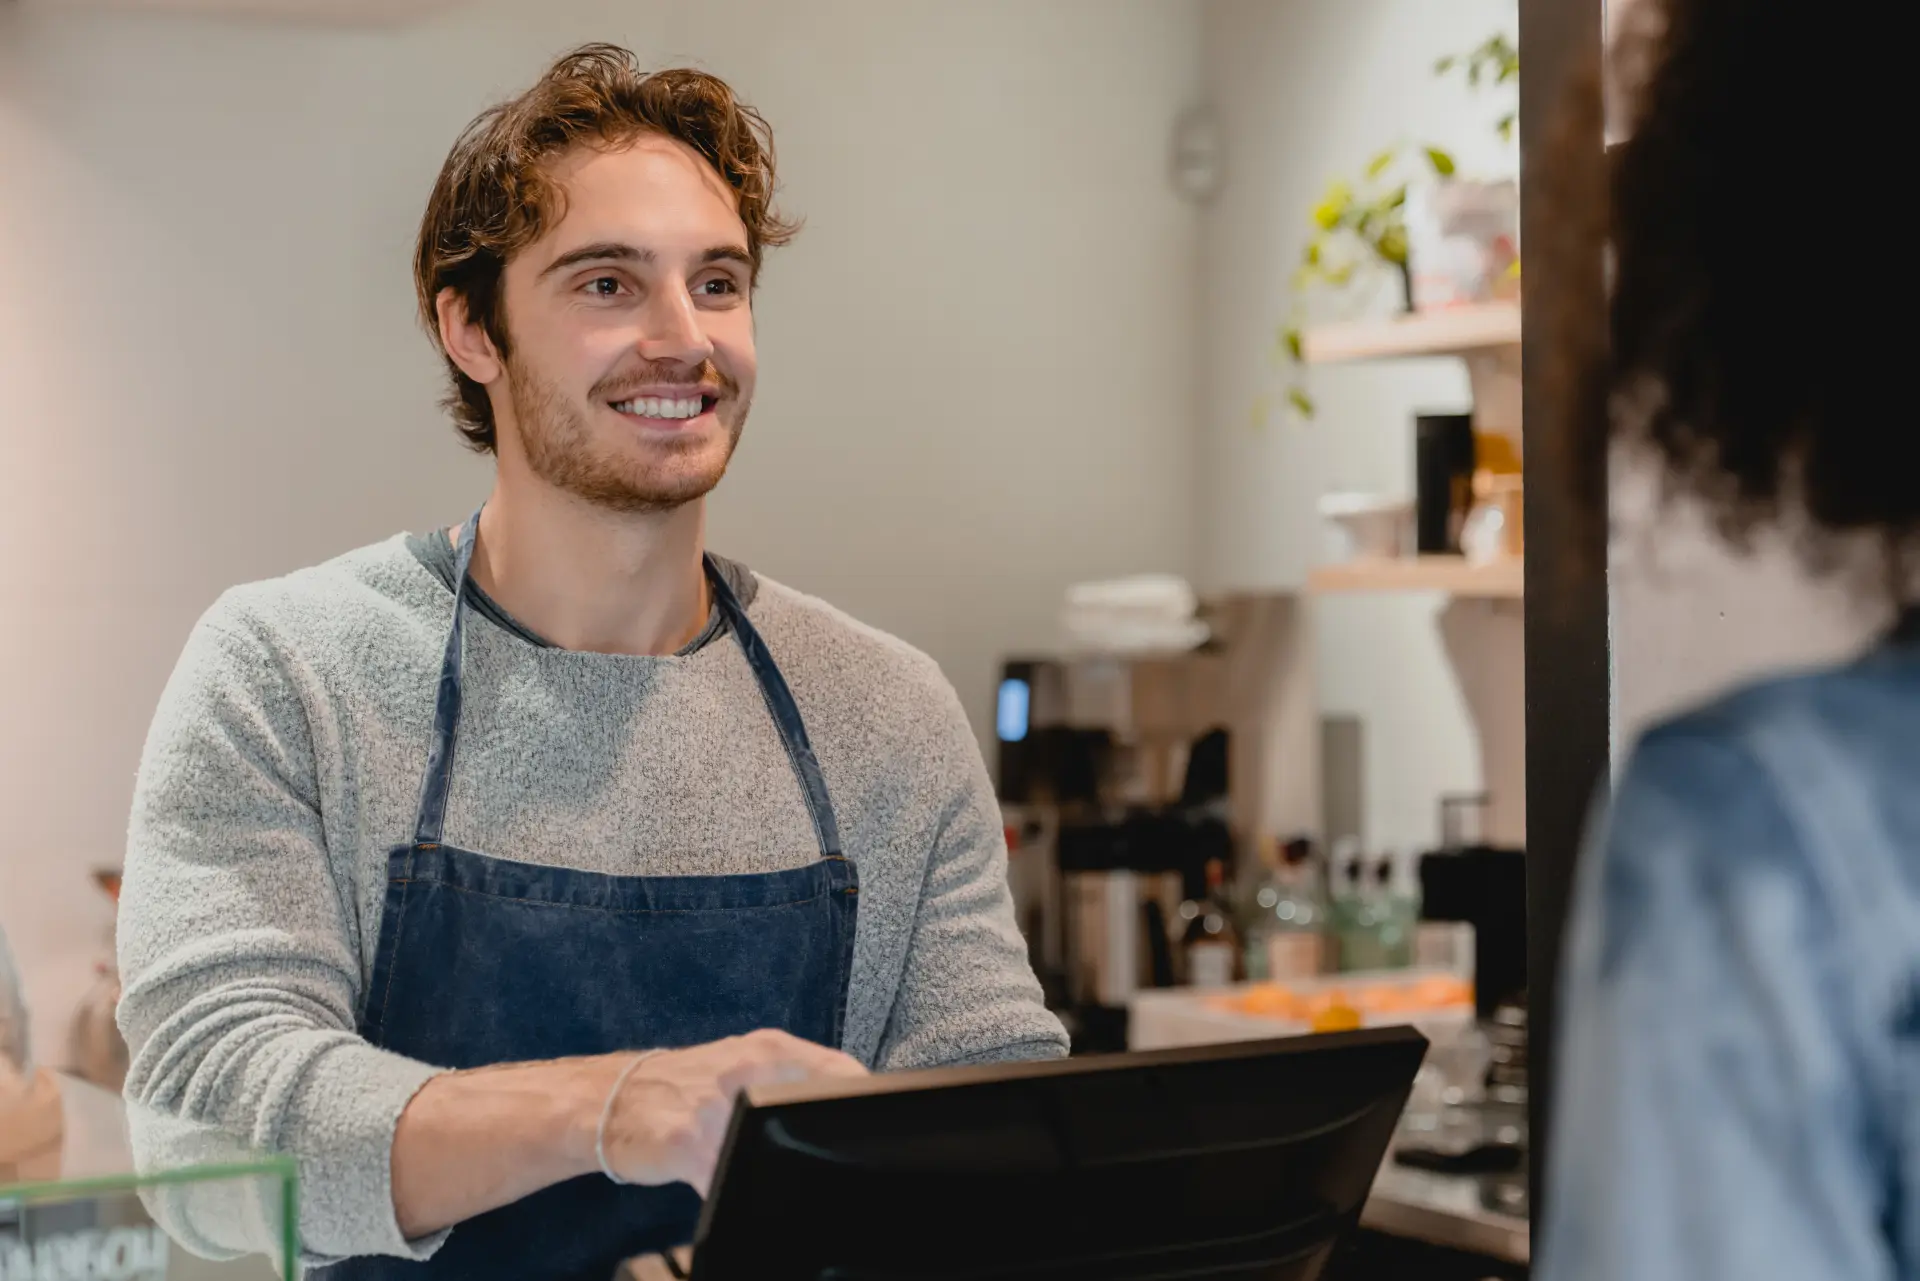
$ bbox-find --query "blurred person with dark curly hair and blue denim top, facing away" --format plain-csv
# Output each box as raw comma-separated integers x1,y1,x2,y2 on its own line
1540,0,1920,1281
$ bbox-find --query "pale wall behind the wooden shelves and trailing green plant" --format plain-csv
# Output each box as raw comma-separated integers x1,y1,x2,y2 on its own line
1196,0,1515,860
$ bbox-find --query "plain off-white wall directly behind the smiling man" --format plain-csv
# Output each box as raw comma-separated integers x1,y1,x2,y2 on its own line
0,0,1200,1045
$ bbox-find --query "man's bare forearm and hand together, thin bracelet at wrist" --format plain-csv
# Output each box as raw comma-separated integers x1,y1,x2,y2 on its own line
392,1031,866,1241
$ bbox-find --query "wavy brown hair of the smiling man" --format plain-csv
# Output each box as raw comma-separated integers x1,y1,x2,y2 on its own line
413,44,799,453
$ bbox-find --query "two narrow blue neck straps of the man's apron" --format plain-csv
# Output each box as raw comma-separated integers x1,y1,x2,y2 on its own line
413,511,841,858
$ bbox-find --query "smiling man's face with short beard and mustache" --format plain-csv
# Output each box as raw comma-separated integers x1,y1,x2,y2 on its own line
492,134,755,511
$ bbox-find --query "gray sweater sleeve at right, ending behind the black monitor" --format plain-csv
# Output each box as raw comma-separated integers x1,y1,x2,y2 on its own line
876,680,1068,1072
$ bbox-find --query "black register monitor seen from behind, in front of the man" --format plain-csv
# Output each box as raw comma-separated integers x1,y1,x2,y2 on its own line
691,1027,1427,1281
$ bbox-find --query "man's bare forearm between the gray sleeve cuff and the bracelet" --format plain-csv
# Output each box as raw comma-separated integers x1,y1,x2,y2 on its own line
394,1054,632,1241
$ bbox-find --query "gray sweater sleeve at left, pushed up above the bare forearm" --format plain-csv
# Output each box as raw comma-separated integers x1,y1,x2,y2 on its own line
119,597,440,1264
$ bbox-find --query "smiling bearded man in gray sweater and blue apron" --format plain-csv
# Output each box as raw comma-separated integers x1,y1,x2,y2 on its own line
119,46,1066,1281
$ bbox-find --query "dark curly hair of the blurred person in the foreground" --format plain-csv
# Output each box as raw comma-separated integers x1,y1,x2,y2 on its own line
1542,0,1920,590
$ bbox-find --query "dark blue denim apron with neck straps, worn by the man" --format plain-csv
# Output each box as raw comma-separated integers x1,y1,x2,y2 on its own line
317,513,858,1281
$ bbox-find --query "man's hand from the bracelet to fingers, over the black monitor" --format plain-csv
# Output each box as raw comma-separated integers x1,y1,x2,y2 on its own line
605,1029,866,1196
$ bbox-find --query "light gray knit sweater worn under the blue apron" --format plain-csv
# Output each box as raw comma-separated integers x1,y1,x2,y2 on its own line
119,536,1066,1262
